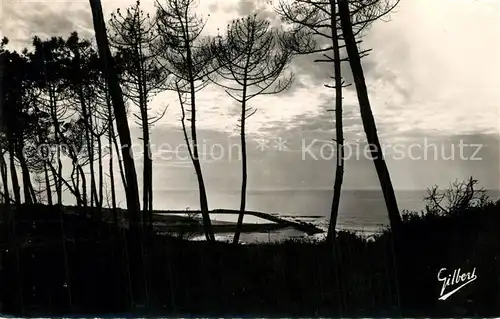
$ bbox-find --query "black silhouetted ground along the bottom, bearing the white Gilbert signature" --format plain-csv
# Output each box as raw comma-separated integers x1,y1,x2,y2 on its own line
0,203,500,317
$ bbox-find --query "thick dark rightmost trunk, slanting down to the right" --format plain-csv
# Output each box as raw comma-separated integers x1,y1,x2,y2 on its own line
338,0,402,235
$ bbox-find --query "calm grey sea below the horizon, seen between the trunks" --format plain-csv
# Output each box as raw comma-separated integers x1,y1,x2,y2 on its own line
150,189,500,241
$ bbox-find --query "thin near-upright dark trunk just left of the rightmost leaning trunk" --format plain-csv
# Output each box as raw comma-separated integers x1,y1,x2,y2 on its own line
326,0,344,242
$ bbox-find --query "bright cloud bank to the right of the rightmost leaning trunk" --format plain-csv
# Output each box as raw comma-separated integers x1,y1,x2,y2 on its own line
360,0,500,134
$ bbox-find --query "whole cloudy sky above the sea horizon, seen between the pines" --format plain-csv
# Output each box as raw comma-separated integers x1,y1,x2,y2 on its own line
0,0,500,202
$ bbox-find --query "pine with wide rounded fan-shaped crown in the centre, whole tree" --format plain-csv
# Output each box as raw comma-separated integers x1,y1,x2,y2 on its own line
212,15,292,244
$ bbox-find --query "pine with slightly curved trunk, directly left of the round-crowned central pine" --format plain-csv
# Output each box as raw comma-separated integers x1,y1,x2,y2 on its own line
155,0,215,241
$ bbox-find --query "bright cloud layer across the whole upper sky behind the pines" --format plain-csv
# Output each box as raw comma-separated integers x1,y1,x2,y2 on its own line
2,0,500,139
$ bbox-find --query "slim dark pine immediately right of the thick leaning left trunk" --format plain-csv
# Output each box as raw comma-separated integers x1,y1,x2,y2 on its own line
110,1,169,227
